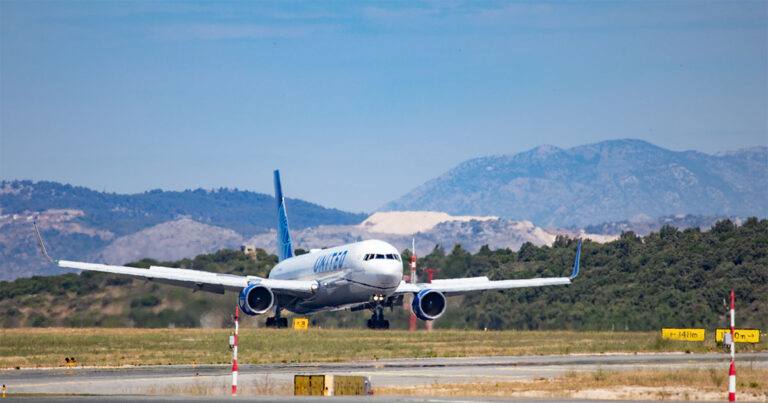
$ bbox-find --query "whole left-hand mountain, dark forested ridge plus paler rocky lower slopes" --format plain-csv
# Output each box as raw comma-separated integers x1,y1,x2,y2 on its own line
0,181,366,280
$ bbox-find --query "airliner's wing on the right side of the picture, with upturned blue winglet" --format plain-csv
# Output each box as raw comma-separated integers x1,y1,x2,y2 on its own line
395,242,581,296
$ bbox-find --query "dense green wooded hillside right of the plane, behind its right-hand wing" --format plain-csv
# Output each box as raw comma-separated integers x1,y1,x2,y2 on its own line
420,218,768,331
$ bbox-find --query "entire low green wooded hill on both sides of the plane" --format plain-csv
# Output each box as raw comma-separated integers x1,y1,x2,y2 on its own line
0,218,768,331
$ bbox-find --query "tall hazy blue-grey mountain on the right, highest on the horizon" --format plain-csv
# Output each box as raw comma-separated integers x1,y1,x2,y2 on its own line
381,140,768,227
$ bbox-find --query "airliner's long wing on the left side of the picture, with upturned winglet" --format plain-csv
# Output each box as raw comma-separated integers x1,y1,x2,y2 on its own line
35,224,318,296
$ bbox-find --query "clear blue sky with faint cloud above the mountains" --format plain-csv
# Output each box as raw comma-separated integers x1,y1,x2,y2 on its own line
0,0,768,212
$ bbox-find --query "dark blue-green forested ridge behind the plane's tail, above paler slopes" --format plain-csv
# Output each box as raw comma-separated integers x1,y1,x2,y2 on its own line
0,181,367,237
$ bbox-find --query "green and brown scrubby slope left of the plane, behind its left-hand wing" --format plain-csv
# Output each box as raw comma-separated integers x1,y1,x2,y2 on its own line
0,250,277,328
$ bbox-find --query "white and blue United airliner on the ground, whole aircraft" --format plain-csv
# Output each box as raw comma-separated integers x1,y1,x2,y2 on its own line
34,170,581,329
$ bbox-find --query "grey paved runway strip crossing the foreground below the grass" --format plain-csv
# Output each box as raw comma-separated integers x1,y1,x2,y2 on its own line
0,353,768,401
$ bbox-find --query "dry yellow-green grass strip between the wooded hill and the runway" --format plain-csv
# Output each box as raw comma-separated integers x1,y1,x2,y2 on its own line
0,328,768,369
